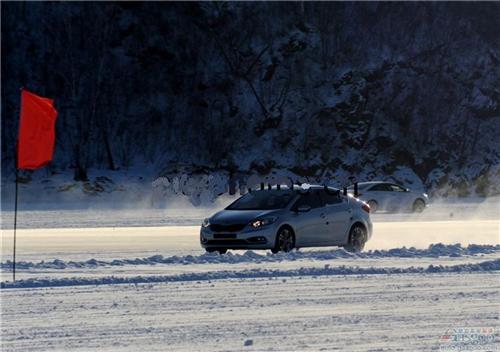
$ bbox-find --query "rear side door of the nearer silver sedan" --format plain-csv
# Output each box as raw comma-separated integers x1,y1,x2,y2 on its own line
321,191,352,246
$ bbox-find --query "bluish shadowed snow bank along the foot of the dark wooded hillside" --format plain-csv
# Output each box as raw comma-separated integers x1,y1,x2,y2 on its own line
1,165,500,216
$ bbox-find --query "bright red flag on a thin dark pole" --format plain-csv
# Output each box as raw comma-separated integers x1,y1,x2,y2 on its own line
17,89,57,170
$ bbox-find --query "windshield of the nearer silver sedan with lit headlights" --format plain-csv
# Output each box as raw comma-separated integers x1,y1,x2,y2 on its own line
226,190,296,210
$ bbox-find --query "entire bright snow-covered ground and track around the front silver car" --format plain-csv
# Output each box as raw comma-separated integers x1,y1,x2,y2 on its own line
0,204,500,351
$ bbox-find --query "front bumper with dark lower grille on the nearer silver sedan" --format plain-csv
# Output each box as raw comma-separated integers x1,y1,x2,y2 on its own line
200,225,276,249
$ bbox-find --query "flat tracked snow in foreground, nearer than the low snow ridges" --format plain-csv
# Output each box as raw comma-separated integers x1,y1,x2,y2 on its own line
1,272,500,351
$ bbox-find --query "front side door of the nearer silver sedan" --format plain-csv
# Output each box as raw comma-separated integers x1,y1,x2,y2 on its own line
292,190,328,247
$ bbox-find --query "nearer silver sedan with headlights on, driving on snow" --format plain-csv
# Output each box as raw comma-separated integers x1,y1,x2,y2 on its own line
200,186,372,253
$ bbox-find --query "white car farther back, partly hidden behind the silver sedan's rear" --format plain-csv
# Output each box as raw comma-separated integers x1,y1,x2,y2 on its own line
348,181,429,213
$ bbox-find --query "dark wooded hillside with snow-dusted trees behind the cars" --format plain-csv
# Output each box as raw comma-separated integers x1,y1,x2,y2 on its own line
2,2,500,195
